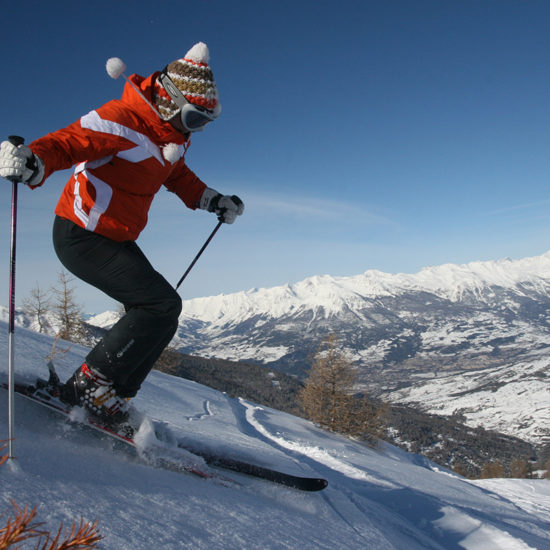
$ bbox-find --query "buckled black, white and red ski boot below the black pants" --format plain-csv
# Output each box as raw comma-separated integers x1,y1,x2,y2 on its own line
59,363,129,425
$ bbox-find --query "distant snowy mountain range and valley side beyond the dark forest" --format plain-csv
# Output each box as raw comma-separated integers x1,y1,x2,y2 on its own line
84,252,550,443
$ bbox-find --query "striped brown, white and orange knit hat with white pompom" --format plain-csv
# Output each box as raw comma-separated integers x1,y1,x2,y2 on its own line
154,42,218,120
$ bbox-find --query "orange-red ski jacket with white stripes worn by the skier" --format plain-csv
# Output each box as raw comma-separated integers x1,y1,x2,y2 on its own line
29,73,206,241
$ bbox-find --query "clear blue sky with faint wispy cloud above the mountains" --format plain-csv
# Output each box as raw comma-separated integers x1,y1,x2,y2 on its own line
0,0,550,312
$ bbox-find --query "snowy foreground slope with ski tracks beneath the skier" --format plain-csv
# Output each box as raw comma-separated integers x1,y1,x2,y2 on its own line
0,322,550,550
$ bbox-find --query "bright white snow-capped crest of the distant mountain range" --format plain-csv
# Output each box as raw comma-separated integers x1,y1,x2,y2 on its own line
87,251,550,330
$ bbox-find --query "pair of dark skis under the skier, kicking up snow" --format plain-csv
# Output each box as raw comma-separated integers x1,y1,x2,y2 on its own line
0,362,328,492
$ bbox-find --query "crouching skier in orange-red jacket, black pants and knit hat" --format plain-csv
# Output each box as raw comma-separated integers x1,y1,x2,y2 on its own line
0,42,244,424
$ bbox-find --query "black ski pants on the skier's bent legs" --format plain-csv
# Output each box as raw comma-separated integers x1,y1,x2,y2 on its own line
53,216,181,397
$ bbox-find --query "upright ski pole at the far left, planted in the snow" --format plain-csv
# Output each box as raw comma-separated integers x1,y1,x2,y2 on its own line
7,136,25,459
